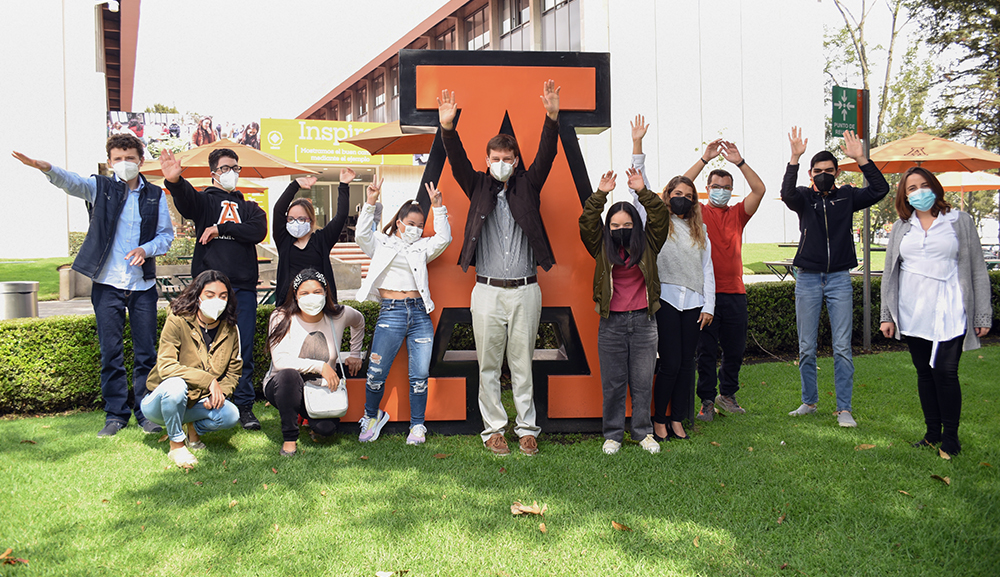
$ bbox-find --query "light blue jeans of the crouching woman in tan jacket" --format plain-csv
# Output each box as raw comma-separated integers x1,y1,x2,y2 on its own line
142,377,240,443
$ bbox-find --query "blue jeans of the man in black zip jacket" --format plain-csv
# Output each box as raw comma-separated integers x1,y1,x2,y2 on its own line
795,269,854,411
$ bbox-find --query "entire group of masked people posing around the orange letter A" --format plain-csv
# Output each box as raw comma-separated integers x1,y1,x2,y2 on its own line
13,80,992,467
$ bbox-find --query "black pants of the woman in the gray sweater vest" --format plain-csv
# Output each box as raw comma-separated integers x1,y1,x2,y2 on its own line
652,299,701,424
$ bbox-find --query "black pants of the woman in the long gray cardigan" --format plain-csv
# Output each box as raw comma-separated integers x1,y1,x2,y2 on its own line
906,335,965,446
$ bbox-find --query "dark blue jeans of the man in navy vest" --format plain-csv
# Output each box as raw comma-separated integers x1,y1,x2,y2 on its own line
90,282,157,424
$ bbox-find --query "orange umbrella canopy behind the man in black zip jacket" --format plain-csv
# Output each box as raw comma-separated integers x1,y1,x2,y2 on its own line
840,132,1000,173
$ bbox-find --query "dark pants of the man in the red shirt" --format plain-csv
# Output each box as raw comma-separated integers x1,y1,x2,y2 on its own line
698,293,747,402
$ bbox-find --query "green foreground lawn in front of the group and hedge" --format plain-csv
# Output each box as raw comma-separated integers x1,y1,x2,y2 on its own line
0,347,1000,577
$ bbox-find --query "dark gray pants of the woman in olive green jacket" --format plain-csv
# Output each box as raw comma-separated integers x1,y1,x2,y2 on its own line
597,309,657,443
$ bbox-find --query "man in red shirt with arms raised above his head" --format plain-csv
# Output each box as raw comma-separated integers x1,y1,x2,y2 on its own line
684,138,764,421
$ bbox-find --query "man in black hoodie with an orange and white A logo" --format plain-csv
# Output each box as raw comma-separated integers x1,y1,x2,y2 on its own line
160,148,267,430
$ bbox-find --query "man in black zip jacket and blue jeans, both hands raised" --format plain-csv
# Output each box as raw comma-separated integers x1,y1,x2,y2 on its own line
781,126,889,427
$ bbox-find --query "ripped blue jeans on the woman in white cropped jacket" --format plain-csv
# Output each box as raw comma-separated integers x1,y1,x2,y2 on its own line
365,298,434,427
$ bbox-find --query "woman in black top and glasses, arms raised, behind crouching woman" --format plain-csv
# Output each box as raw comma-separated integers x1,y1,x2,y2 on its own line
271,168,356,303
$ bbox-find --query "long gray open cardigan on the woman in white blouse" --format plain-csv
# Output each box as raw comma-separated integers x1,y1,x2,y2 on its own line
881,211,993,351
